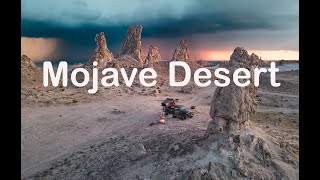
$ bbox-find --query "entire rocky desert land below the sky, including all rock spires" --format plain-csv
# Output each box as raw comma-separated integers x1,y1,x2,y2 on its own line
21,26,299,180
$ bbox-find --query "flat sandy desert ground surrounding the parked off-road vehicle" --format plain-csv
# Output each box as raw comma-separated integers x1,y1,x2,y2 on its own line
21,67,299,179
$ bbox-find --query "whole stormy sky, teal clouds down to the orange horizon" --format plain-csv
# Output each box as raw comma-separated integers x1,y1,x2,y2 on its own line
21,0,299,62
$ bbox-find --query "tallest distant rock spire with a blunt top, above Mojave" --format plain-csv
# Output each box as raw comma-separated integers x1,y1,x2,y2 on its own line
119,25,142,62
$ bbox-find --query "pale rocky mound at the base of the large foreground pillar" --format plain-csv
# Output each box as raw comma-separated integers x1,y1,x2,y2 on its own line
176,128,299,180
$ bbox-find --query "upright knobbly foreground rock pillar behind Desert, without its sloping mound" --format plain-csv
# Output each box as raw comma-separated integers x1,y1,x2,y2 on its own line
208,47,257,133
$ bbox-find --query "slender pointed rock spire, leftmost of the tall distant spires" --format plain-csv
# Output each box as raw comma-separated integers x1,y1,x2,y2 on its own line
88,32,113,67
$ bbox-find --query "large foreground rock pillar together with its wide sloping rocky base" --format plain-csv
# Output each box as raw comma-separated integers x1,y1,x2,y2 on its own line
180,48,299,180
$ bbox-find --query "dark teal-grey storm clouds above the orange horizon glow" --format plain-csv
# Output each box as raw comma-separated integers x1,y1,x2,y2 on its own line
22,0,299,61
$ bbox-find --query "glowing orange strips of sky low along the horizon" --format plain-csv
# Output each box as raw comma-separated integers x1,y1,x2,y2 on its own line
21,37,299,61
